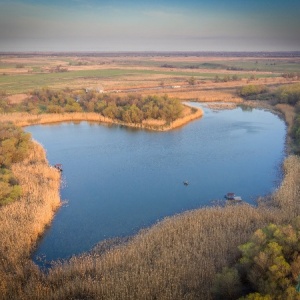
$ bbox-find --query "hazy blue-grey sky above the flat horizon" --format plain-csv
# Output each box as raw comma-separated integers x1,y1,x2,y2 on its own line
0,0,300,51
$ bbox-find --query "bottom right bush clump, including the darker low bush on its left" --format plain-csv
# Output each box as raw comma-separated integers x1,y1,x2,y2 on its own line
213,216,300,300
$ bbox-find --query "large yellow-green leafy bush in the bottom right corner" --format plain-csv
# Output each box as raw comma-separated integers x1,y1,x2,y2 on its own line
239,217,300,299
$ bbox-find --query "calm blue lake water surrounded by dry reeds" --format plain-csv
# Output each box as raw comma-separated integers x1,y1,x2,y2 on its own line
27,104,286,260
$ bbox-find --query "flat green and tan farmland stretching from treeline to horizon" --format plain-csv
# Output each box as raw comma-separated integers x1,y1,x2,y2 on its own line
0,53,300,102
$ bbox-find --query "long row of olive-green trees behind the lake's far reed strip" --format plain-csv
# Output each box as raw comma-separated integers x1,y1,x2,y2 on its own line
0,89,183,124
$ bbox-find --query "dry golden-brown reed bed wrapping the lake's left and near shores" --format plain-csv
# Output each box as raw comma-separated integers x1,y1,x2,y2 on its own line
0,111,300,300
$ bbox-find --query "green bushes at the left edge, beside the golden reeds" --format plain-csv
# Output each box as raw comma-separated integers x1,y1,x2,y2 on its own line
0,123,31,206
